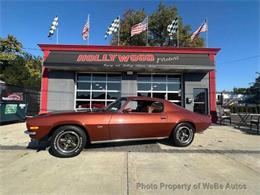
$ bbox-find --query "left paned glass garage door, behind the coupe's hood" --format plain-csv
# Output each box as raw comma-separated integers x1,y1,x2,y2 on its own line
76,73,121,109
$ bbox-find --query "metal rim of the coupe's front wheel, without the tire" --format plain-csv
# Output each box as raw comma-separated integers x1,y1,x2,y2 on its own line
56,131,81,153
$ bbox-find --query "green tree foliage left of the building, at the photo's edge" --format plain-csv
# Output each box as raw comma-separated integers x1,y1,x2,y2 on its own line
0,35,41,88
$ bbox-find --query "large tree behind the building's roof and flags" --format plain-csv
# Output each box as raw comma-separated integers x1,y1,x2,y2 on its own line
111,3,204,47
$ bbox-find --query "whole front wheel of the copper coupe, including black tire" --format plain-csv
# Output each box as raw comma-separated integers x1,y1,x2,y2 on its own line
50,125,87,158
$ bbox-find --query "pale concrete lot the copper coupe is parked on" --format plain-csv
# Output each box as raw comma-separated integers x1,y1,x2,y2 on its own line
0,123,260,195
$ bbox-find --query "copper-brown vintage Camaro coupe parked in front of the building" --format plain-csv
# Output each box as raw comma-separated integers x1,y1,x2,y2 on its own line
26,97,211,157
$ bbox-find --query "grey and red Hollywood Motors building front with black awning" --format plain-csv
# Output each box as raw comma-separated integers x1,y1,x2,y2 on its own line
39,44,220,121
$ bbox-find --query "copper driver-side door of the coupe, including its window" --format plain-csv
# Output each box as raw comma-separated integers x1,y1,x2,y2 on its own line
109,100,170,140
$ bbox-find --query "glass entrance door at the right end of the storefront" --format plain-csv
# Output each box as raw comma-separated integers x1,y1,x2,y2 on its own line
193,88,208,114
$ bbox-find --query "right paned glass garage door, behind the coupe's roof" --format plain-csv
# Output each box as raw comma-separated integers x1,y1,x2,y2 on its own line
137,74,181,105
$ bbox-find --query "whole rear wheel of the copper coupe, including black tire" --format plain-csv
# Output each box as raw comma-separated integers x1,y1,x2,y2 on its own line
172,123,195,147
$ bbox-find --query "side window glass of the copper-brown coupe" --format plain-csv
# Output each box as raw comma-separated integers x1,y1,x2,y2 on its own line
125,100,163,113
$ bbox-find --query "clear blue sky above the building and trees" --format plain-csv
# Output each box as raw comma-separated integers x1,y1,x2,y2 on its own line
0,0,260,91
